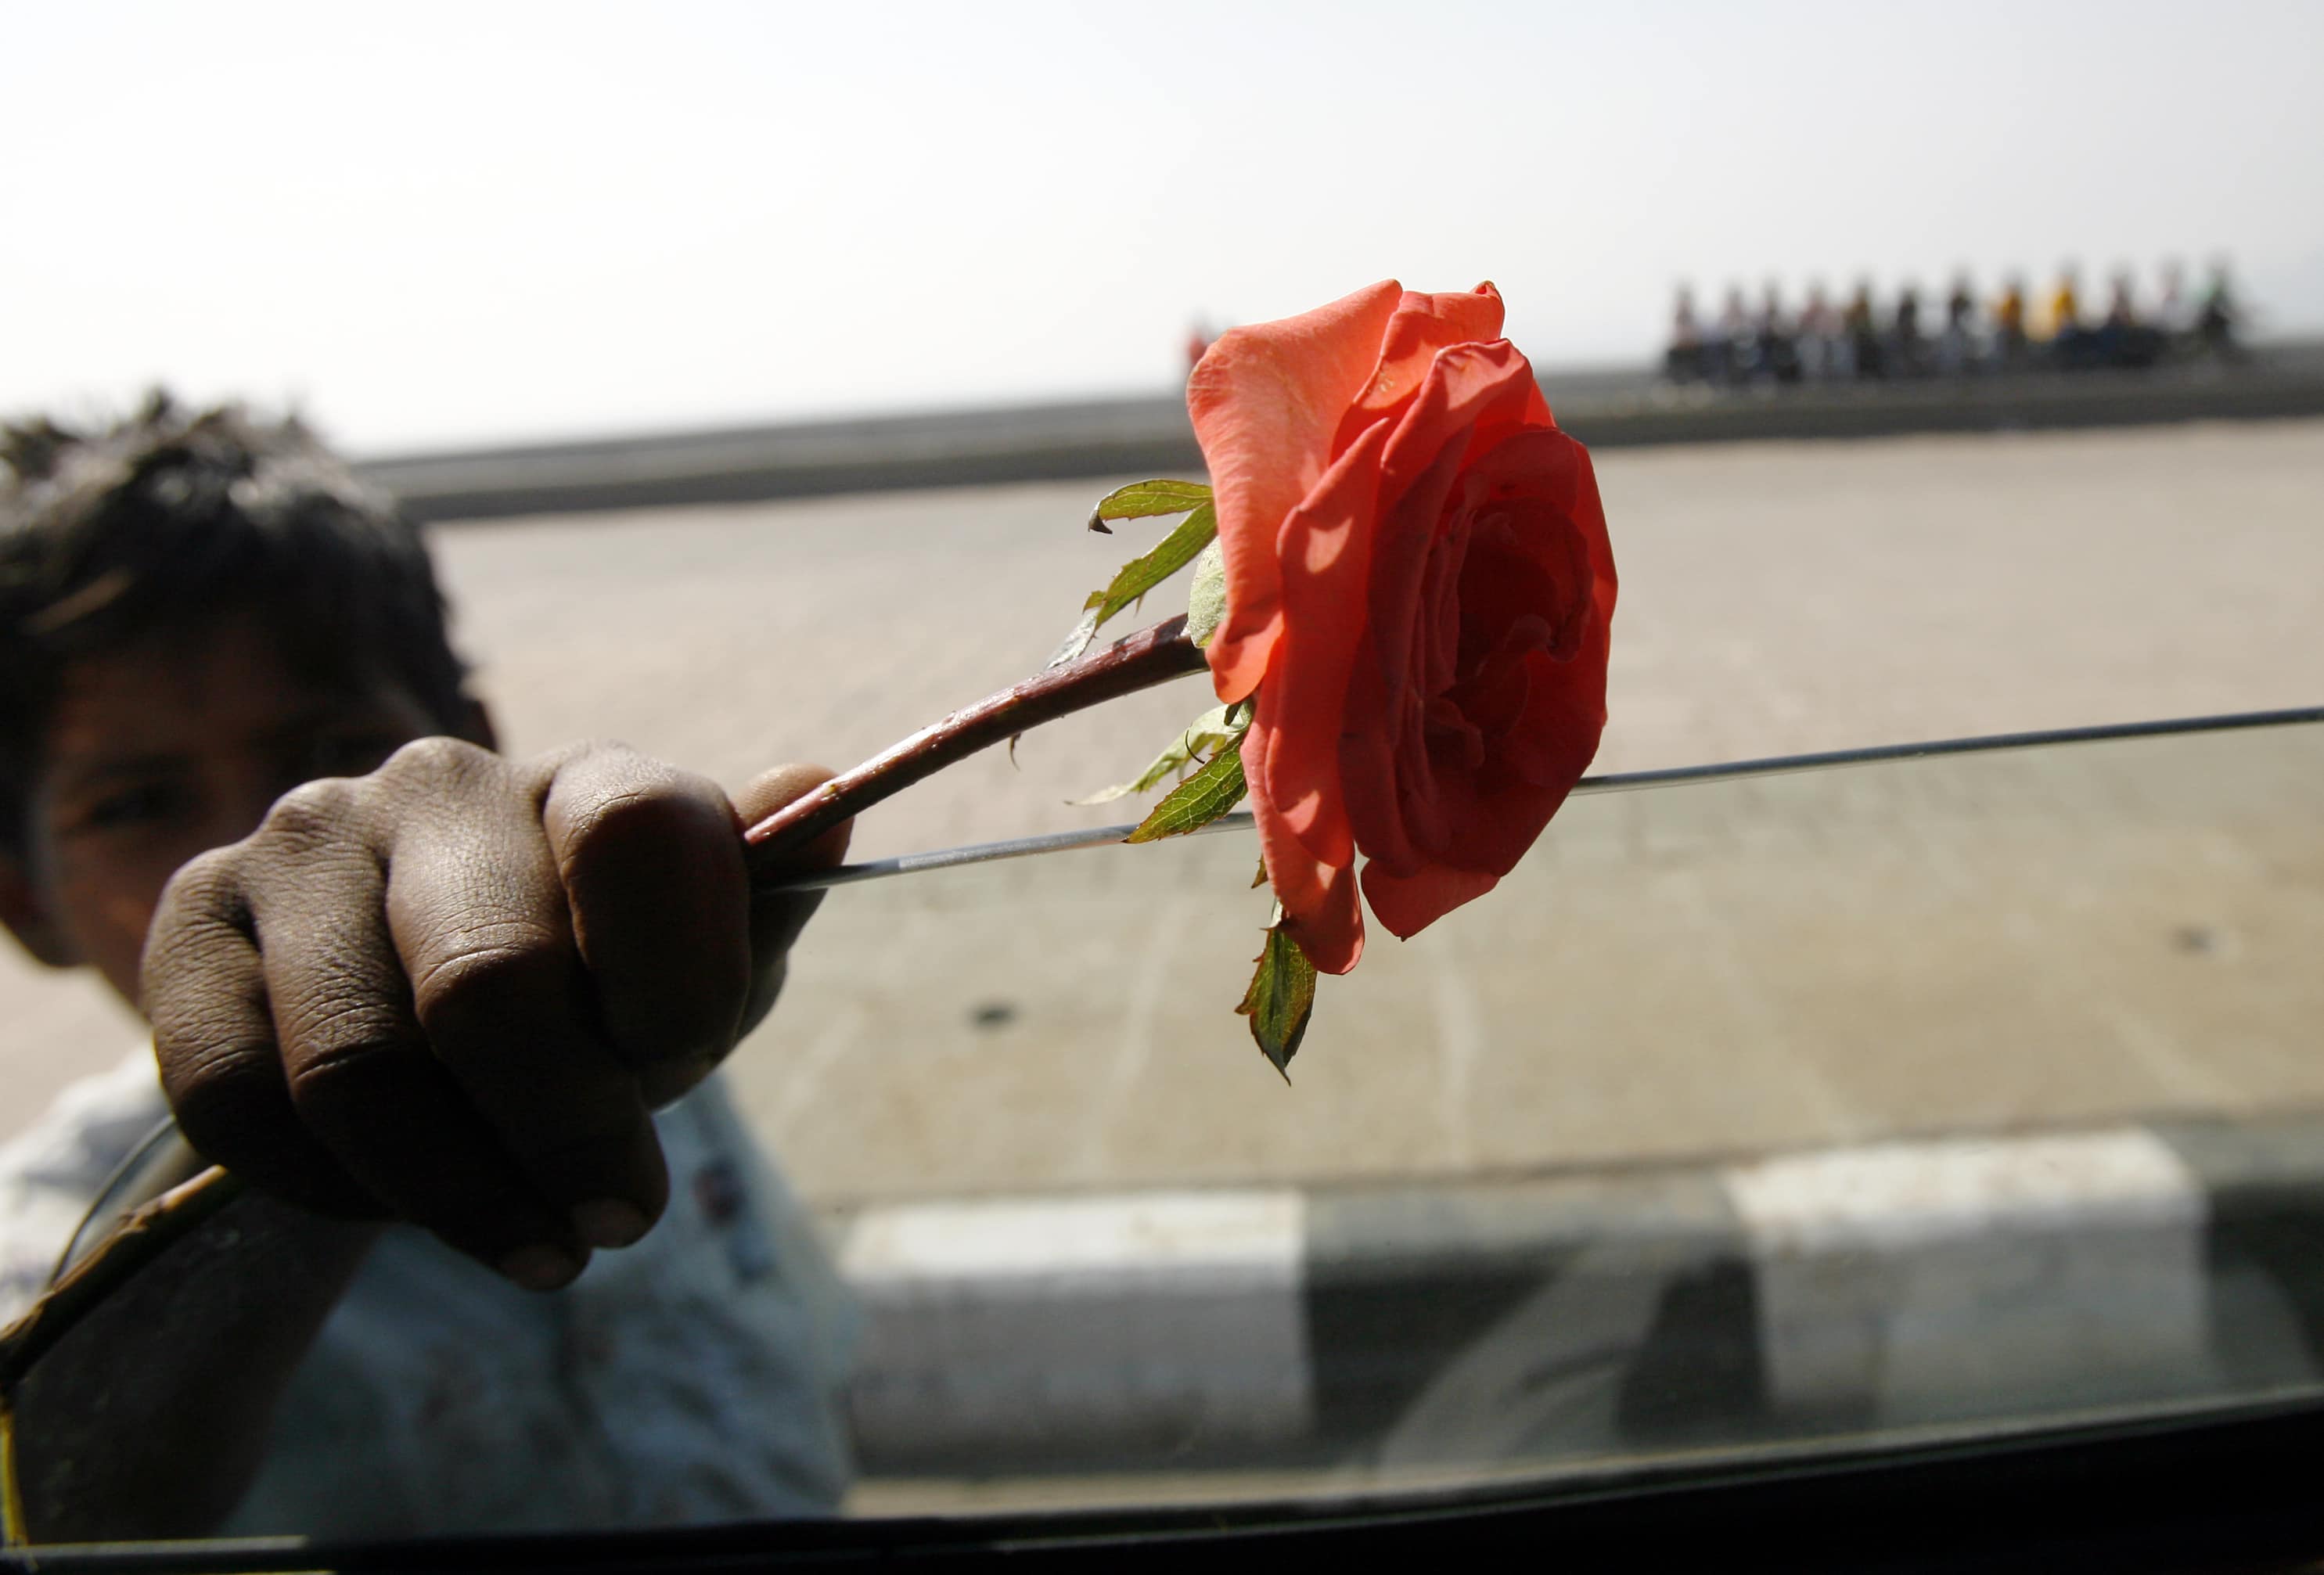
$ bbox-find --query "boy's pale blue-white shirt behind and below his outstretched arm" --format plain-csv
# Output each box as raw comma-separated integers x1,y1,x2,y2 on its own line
0,1055,853,1537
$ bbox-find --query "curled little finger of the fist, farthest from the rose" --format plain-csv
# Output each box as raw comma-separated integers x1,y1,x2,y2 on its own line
139,850,386,1217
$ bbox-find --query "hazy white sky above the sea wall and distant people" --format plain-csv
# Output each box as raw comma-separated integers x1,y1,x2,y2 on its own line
0,0,2324,451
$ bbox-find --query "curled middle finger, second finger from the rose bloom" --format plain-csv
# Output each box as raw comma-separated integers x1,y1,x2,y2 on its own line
383,752,669,1247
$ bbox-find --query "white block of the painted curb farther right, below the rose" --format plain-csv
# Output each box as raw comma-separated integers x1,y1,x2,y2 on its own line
1722,1129,2217,1424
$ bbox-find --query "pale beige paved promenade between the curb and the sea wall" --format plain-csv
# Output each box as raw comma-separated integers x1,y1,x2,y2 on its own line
0,423,2324,1201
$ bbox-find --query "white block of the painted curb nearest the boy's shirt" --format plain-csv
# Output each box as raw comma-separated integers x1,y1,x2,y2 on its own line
839,1192,1313,1459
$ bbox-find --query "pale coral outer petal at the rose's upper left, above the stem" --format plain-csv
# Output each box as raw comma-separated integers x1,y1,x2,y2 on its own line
1185,279,1404,702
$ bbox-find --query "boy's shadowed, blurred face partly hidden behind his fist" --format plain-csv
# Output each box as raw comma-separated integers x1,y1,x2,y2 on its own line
0,616,441,1004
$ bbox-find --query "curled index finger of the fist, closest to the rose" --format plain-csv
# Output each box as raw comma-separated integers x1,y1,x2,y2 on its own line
541,748,750,1076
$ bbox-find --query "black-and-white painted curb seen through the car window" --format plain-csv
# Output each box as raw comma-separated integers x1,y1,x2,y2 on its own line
834,1120,2324,1475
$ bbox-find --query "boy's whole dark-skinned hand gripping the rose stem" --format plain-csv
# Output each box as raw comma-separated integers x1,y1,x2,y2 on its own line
144,739,846,1287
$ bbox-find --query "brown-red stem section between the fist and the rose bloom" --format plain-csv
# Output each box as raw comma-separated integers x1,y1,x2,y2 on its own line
741,618,1203,878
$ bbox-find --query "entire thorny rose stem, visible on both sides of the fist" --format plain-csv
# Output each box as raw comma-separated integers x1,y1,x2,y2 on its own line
0,618,1203,1489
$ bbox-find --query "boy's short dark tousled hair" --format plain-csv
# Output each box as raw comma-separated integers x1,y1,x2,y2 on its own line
0,393,467,848
